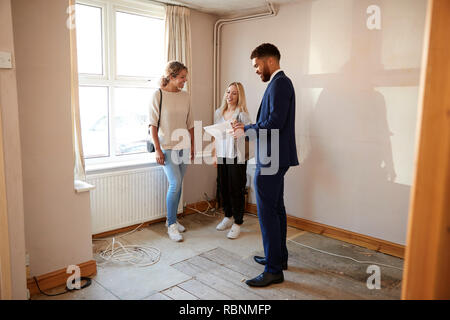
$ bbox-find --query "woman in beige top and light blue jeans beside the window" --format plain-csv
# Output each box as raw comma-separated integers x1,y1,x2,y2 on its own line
150,61,194,241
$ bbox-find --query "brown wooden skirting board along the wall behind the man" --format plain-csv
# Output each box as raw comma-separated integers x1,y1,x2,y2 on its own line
246,203,405,259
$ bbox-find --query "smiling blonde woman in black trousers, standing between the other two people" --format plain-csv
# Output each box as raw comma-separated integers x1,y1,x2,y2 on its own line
213,82,251,239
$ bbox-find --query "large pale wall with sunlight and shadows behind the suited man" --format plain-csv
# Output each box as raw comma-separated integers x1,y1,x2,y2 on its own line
219,0,427,244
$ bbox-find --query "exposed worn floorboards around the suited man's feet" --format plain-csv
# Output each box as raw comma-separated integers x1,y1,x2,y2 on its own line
147,234,401,300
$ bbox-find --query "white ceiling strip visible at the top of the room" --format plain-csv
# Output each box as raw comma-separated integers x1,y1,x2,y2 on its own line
150,0,301,17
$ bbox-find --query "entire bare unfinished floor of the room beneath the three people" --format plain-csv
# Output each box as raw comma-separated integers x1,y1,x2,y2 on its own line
32,213,403,300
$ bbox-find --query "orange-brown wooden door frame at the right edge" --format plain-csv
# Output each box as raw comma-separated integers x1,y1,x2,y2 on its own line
402,0,450,299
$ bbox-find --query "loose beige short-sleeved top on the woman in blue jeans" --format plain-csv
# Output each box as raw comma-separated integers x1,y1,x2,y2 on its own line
149,90,194,150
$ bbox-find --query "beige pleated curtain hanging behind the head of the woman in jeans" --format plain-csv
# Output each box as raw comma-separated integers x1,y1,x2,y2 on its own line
165,5,192,93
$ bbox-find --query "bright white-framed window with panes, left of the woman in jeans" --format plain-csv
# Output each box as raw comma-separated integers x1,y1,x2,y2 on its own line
76,0,165,165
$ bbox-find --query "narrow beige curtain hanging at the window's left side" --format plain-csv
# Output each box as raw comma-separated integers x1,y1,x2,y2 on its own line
68,0,86,181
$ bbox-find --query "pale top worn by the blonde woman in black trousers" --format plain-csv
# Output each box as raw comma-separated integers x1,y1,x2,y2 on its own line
214,108,251,159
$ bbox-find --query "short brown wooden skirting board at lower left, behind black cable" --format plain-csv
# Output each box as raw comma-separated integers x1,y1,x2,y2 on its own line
27,260,97,296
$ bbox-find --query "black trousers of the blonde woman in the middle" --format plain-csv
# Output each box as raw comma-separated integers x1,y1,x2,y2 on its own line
217,157,247,225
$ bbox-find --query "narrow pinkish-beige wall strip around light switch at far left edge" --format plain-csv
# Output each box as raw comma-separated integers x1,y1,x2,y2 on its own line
0,0,27,299
